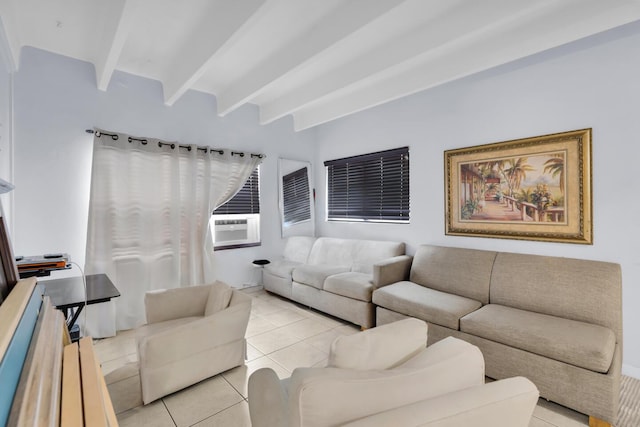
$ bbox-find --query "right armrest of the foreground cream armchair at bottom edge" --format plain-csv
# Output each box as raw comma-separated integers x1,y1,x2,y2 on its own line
345,377,539,427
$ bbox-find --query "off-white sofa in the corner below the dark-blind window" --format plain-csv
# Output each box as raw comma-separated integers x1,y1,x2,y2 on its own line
263,237,411,328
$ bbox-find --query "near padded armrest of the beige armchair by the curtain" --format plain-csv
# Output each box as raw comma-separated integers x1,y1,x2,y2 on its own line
138,298,251,368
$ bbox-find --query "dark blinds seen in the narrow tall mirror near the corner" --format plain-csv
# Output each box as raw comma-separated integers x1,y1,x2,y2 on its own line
282,167,311,225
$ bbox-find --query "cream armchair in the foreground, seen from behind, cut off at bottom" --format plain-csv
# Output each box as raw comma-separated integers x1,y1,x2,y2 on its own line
249,319,538,427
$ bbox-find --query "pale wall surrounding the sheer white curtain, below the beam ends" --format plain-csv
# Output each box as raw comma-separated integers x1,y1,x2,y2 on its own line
13,48,313,286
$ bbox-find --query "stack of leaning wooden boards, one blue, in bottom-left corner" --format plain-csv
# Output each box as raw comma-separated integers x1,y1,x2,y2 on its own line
0,278,118,427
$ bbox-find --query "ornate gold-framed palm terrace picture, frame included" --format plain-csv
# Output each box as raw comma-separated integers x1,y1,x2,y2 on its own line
444,128,593,245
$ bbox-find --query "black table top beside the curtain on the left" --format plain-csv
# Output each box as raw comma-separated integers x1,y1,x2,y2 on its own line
38,274,120,309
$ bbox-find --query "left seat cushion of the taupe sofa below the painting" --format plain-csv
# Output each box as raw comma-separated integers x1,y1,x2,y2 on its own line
373,281,482,330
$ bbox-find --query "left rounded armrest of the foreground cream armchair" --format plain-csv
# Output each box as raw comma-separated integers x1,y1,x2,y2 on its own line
248,368,289,427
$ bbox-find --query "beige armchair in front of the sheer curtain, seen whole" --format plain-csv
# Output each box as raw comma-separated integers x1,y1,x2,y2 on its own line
136,282,251,405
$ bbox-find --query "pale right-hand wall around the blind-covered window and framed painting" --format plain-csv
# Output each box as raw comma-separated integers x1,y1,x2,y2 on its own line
315,23,640,378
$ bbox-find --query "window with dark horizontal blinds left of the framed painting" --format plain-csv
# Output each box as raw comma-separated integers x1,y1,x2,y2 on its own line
324,147,409,222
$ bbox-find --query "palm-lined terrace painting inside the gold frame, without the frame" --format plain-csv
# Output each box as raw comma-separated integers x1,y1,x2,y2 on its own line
459,151,566,223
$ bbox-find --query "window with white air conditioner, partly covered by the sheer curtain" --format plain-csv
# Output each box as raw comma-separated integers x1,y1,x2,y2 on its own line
210,168,260,250
